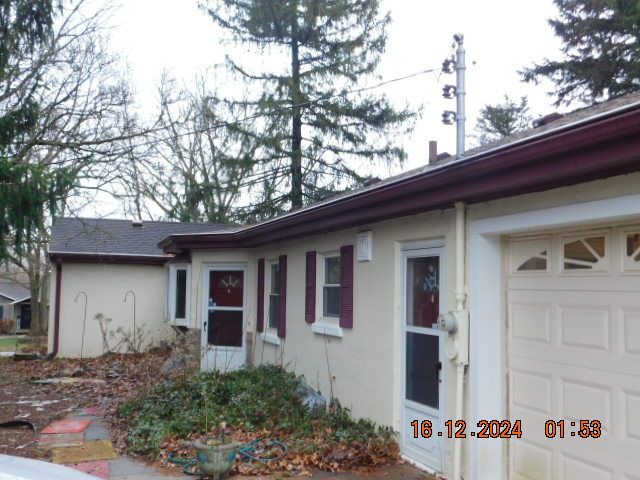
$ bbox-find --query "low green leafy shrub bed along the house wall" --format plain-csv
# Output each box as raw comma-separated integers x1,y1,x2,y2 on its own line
118,366,393,455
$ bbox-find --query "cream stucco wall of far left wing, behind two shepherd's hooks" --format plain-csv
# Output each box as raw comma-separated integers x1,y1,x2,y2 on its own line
49,263,173,357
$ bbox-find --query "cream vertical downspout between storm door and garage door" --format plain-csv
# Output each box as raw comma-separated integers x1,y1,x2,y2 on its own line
453,202,469,480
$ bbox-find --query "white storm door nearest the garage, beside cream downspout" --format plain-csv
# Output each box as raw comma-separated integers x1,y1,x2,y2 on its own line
400,248,444,472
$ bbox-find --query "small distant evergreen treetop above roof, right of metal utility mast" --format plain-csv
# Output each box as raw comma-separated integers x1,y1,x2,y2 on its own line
476,95,532,145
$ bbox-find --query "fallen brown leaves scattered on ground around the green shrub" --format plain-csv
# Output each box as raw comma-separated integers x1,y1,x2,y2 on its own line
0,352,399,476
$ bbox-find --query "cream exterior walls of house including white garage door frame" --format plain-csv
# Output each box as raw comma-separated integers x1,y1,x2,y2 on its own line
45,174,640,480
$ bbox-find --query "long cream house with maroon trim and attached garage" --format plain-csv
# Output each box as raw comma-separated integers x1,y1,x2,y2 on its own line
49,95,640,480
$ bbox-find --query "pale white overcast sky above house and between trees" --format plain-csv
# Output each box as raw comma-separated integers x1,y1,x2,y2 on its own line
112,0,560,180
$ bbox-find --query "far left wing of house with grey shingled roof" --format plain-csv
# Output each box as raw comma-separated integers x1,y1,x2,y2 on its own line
49,218,237,357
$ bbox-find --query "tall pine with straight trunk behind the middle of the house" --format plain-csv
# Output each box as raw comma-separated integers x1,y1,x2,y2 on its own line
203,0,413,216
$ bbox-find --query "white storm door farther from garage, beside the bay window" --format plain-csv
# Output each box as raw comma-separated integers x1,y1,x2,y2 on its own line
202,267,247,371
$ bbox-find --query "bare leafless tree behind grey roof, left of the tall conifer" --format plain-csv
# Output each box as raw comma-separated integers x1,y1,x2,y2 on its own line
121,75,258,223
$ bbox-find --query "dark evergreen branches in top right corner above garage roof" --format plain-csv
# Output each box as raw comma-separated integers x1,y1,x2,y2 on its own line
521,0,640,105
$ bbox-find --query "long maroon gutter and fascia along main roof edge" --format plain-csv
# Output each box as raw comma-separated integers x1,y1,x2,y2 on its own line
159,103,640,252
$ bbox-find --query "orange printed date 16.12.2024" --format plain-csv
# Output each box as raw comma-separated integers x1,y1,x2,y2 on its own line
410,420,522,438
